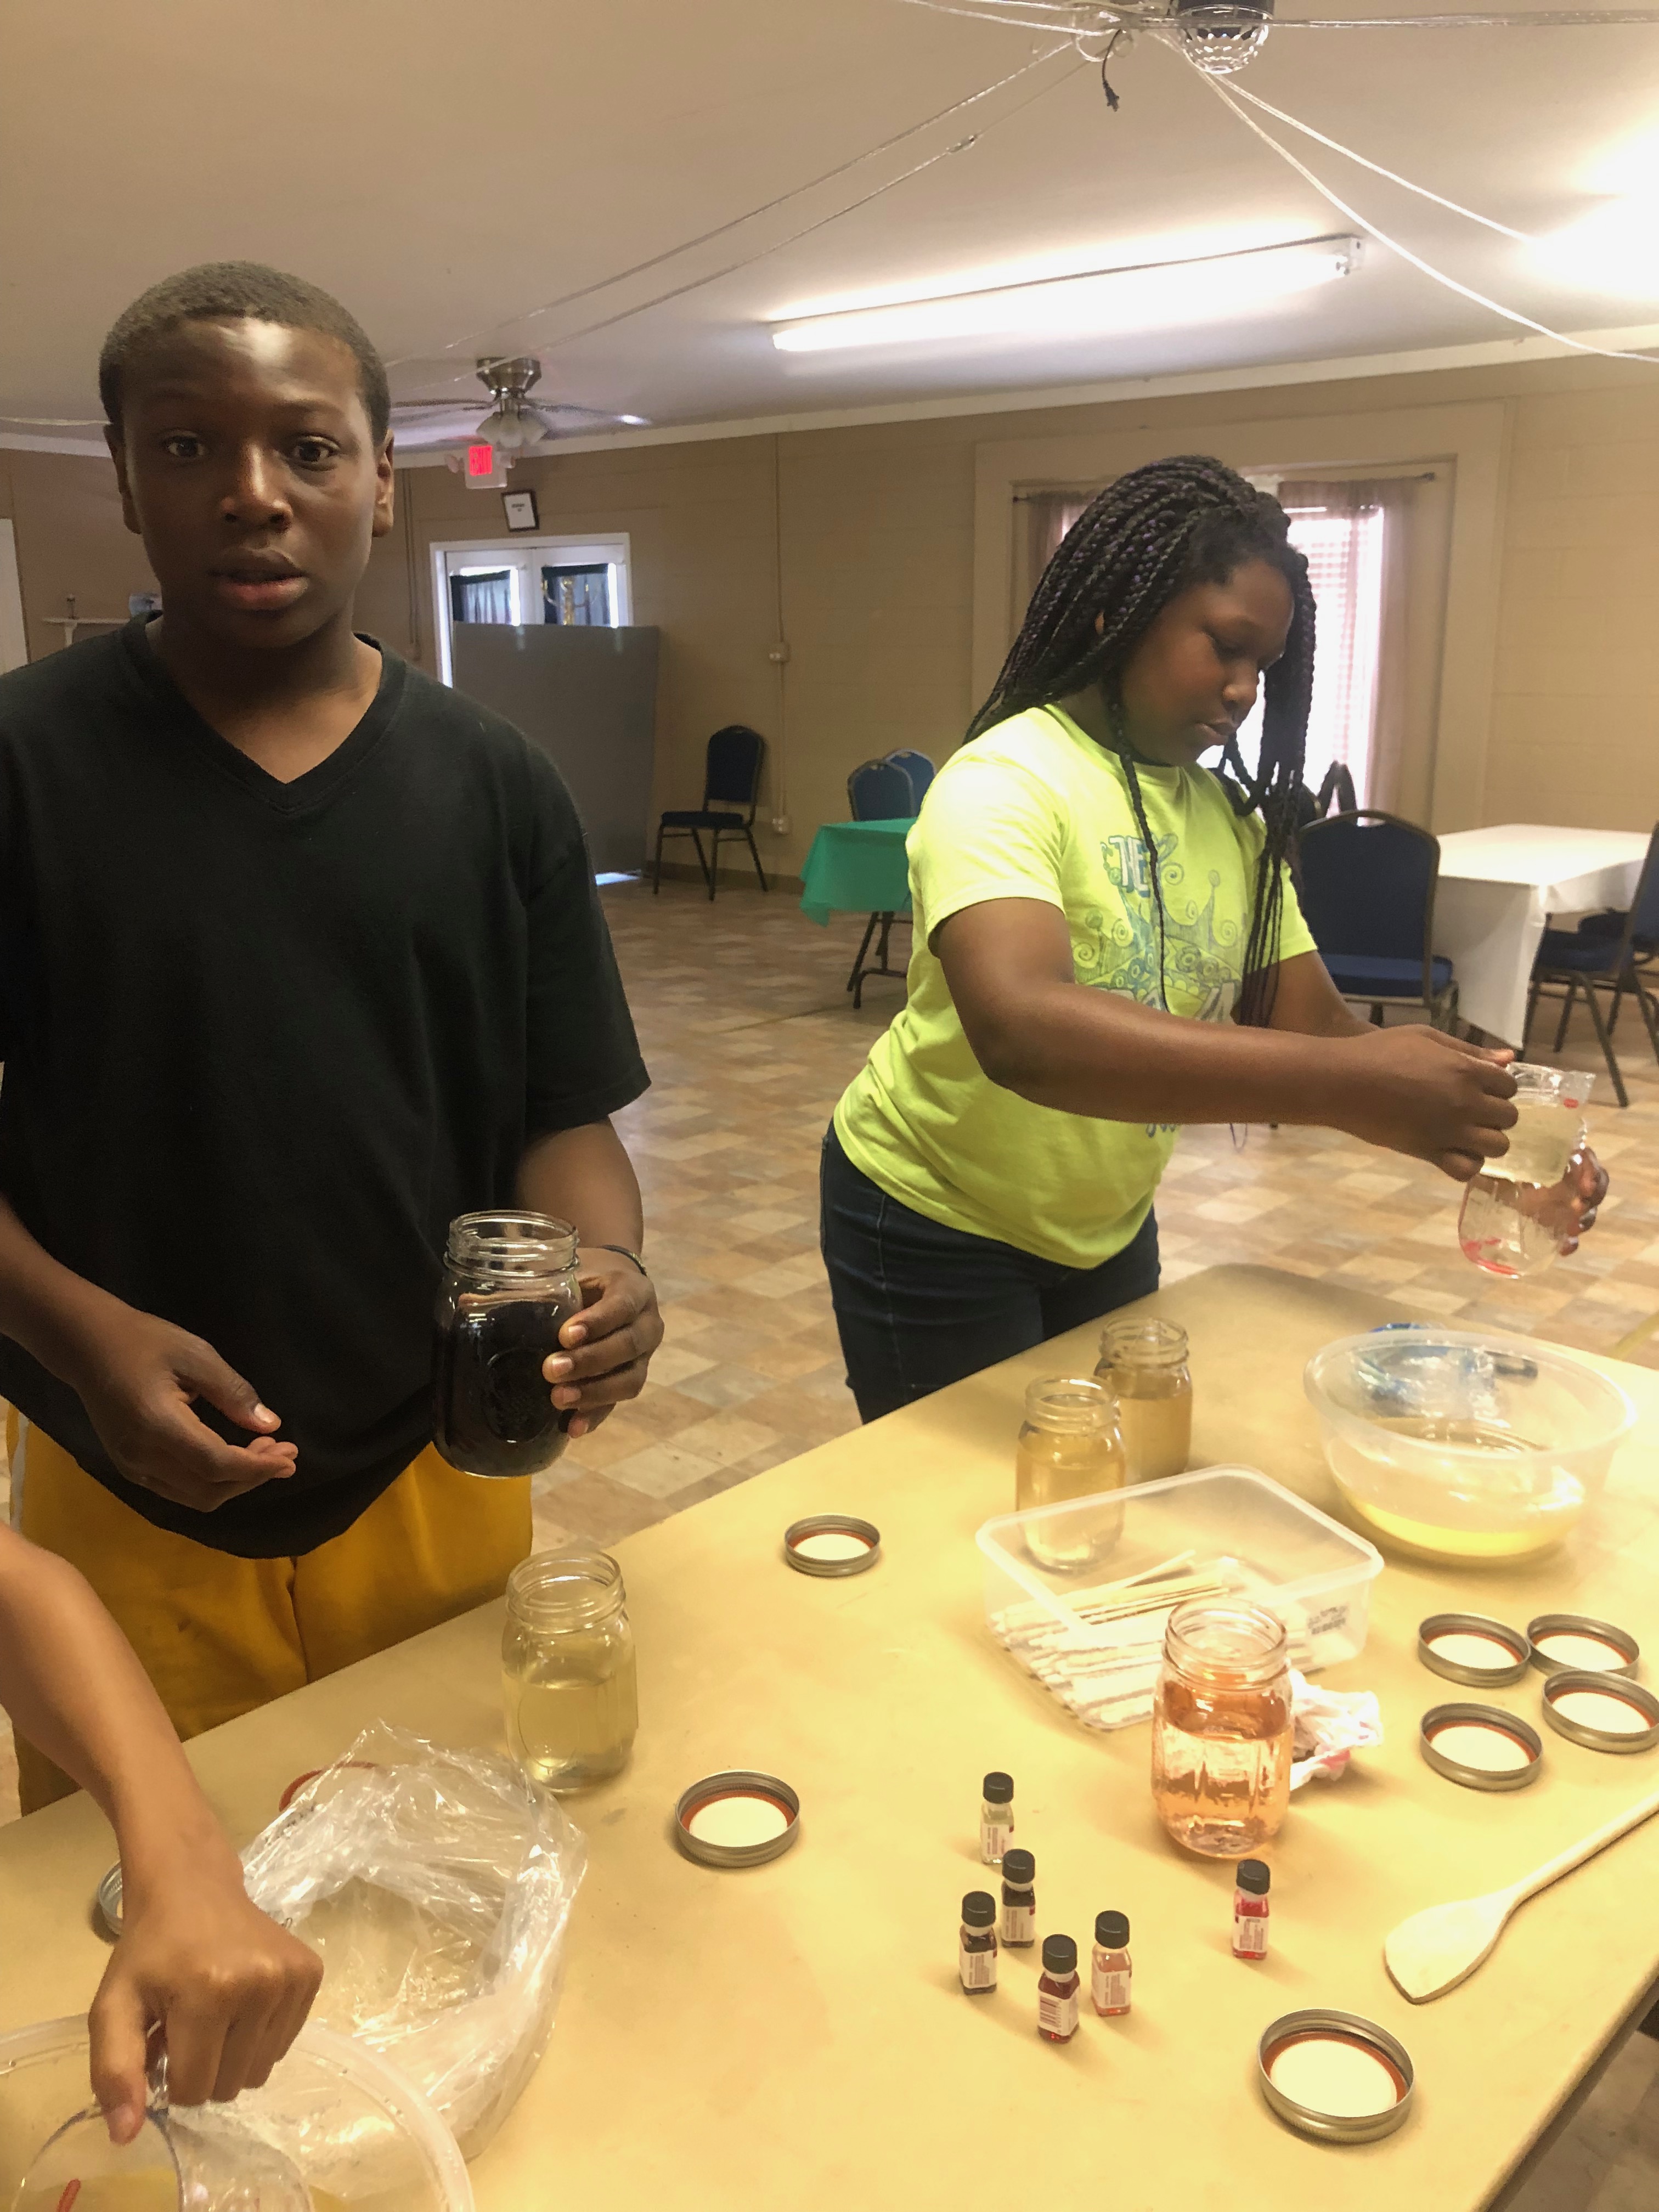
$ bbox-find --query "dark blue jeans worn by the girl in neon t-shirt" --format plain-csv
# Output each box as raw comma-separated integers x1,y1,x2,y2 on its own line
819,1128,1159,1420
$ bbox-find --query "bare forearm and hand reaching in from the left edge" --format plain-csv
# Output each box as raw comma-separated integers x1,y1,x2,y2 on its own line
0,1528,323,2143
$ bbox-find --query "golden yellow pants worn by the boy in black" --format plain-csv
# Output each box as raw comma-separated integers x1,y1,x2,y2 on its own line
7,1413,531,1812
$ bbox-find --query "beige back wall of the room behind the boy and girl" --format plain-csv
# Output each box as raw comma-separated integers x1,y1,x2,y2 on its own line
0,347,1659,872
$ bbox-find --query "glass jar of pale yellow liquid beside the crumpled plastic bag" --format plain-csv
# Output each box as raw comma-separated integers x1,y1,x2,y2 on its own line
502,1548,639,1790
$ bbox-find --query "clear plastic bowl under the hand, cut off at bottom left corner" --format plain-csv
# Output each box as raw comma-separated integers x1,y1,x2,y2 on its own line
0,2017,473,2212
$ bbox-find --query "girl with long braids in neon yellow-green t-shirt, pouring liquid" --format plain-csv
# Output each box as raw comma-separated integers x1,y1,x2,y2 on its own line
823,458,1606,1420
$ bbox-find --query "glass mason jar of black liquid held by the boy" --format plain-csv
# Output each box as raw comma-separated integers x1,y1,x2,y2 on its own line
431,1212,582,1475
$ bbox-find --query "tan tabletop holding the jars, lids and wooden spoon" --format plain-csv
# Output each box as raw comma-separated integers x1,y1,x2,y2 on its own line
0,1267,1659,2212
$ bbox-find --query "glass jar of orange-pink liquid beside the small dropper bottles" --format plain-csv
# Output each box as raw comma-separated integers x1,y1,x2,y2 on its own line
1153,1599,1292,1858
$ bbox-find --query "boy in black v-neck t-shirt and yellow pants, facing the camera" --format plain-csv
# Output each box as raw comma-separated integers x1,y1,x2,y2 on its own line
0,263,662,1805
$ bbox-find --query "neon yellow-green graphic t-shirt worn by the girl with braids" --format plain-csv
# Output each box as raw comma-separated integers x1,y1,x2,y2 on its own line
836,708,1314,1267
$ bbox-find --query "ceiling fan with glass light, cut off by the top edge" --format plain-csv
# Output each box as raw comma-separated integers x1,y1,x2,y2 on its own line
909,0,1659,77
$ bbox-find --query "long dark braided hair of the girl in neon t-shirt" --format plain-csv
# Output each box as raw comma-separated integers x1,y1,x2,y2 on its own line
967,454,1314,1026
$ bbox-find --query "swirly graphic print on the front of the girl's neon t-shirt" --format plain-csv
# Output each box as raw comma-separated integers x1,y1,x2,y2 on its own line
1073,834,1243,1022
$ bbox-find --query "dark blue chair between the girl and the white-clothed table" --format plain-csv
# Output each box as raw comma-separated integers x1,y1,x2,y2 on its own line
1299,808,1458,1029
